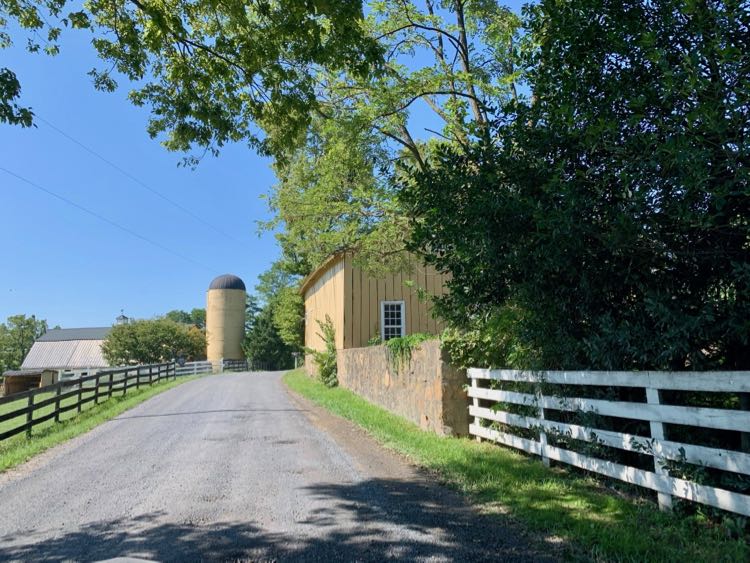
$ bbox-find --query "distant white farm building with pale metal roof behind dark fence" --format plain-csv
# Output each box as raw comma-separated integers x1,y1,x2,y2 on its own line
21,327,111,379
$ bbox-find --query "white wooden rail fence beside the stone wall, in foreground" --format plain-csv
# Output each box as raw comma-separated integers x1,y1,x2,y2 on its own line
468,369,750,516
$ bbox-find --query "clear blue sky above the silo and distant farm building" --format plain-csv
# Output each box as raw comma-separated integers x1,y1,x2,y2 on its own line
0,1,521,327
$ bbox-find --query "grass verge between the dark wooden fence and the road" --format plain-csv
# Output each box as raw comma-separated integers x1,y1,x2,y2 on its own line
0,376,200,472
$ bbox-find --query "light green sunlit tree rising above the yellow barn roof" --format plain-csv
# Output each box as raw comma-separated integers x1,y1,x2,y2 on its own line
267,0,522,275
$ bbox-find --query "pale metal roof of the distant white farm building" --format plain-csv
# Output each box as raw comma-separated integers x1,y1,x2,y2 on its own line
21,338,109,369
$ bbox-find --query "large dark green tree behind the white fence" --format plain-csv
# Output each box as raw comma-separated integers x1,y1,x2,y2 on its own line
404,0,750,369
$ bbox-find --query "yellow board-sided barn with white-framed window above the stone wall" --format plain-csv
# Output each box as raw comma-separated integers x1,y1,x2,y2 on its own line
300,253,448,363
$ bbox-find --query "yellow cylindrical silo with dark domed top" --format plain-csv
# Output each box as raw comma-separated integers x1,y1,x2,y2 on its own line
206,274,247,362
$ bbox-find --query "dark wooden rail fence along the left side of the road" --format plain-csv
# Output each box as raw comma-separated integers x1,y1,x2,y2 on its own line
0,362,177,441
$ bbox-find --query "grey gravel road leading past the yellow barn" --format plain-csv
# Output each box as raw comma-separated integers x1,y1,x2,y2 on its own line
0,373,560,561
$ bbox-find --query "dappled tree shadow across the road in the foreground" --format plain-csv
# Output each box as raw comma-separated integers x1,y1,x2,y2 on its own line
0,480,567,561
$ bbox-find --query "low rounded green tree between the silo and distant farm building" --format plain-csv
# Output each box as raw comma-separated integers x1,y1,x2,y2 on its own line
102,319,206,366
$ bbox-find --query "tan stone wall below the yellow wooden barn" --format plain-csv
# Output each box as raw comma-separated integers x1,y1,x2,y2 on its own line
337,340,469,436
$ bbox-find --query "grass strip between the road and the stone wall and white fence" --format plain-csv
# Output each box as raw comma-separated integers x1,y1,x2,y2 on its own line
284,370,750,562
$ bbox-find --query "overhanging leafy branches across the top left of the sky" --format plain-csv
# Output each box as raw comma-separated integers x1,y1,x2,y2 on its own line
0,0,380,160
